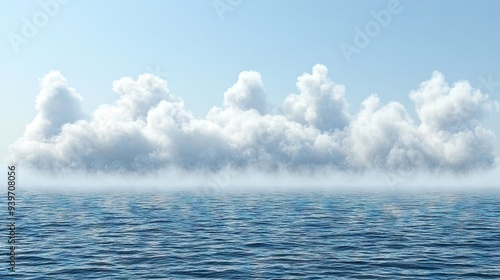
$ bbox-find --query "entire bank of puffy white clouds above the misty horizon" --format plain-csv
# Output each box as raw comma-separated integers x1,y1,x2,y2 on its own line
9,64,499,173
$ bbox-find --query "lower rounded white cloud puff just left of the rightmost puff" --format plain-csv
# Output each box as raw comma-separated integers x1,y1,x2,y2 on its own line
344,95,426,170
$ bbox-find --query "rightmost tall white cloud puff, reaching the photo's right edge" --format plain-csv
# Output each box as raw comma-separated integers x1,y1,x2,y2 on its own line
410,72,498,170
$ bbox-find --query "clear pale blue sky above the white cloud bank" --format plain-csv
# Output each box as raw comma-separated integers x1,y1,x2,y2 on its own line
0,0,500,179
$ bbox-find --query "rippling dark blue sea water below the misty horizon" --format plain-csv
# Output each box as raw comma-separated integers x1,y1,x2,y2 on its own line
0,191,500,279
